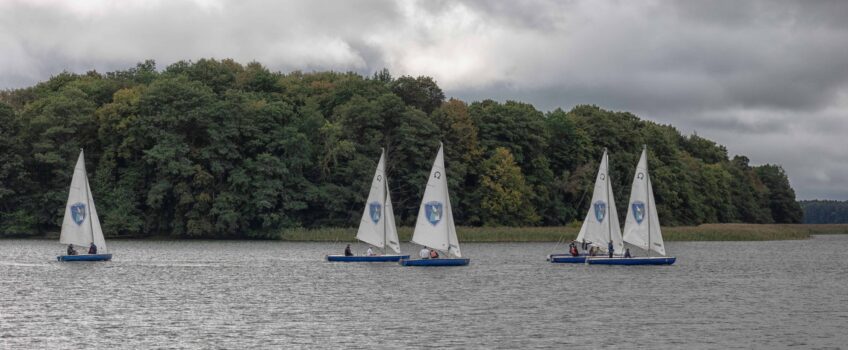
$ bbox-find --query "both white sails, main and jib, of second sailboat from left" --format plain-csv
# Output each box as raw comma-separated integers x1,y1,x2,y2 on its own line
356,150,400,253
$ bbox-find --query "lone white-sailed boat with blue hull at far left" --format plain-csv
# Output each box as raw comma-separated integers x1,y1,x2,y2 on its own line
56,150,112,261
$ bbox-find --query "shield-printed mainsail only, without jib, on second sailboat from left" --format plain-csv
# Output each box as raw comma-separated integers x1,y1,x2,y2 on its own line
356,151,394,248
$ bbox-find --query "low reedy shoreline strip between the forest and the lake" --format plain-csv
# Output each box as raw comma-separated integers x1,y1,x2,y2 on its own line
8,224,848,243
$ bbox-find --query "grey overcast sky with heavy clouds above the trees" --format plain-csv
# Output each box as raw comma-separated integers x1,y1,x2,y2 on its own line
0,0,848,200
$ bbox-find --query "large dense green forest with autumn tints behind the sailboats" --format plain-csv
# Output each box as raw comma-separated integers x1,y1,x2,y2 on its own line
0,59,802,238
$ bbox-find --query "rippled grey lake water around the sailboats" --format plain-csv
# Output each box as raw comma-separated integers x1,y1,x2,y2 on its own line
0,235,848,349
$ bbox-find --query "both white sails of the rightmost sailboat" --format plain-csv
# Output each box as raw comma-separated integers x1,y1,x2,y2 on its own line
624,150,665,256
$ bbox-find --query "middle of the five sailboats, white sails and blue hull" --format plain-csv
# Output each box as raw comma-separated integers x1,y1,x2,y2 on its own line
400,142,471,266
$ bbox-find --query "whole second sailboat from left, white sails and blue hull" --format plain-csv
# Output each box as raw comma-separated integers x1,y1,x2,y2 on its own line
327,149,409,262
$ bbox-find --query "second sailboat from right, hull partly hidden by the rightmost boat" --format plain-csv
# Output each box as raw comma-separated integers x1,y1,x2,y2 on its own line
548,148,624,263
